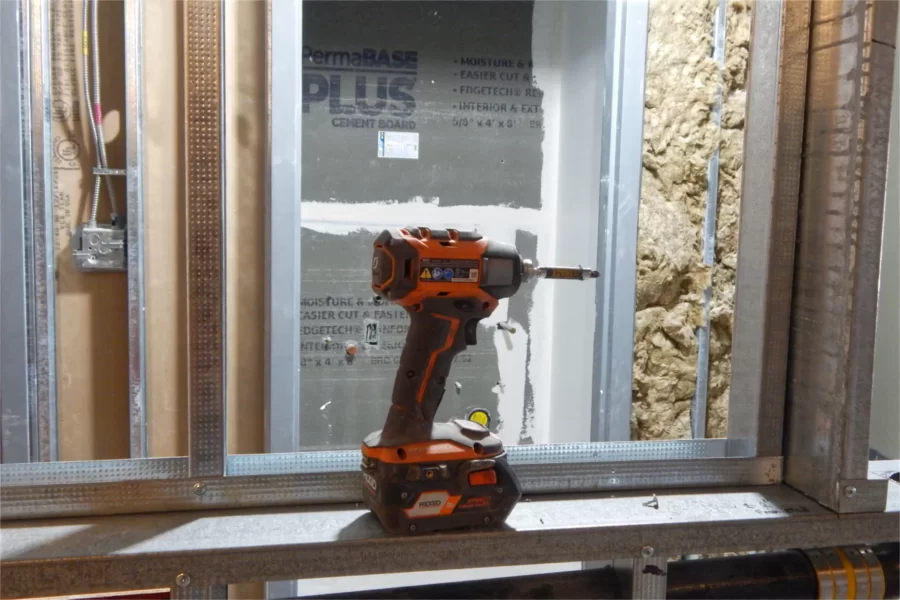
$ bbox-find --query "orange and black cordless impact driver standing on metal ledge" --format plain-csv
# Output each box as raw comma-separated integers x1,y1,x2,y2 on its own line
362,227,598,533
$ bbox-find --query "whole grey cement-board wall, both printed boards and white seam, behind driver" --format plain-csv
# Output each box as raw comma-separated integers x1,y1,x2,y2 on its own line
298,2,543,447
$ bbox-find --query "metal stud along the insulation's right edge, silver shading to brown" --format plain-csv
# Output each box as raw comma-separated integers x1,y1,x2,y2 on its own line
728,0,810,456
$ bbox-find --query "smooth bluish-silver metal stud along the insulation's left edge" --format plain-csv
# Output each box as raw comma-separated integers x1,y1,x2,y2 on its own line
591,0,650,441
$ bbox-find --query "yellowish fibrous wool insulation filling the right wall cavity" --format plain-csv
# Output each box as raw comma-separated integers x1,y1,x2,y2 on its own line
632,0,750,440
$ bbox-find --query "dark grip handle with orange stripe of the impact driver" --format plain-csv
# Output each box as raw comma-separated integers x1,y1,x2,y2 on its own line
382,298,493,445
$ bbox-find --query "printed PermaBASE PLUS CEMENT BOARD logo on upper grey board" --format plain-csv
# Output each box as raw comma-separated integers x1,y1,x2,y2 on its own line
303,46,419,131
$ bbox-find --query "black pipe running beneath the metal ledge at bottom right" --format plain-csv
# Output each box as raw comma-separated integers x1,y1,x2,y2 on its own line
312,543,900,600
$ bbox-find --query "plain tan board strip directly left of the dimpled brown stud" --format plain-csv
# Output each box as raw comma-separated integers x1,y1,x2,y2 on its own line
144,2,188,456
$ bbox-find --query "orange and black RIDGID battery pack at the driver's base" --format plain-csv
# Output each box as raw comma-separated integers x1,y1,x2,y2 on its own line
362,419,522,535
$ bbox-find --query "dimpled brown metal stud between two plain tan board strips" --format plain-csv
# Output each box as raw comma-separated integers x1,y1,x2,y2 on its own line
184,0,225,476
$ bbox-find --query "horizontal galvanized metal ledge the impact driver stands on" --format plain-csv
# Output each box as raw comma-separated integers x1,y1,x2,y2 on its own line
0,482,900,597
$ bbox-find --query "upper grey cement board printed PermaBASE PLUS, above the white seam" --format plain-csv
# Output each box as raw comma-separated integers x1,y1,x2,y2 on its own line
303,2,542,208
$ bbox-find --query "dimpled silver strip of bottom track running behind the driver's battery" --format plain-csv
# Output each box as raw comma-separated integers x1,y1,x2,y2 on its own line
0,439,726,485
